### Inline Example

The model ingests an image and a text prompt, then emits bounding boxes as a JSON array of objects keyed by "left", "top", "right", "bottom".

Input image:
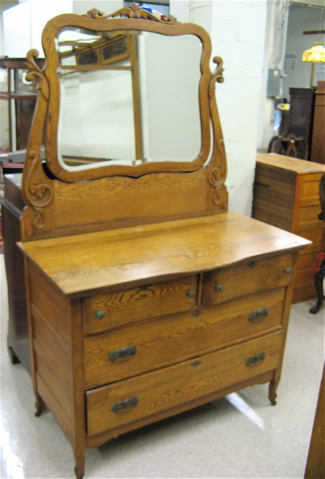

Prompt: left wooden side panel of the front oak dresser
[{"left": 27, "top": 261, "right": 74, "bottom": 440}]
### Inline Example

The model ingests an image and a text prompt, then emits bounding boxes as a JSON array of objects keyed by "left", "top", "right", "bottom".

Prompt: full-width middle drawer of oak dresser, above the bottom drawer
[{"left": 84, "top": 288, "right": 285, "bottom": 389}]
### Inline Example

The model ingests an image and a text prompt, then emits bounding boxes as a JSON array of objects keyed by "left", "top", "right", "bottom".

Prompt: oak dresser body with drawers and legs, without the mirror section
[{"left": 21, "top": 213, "right": 308, "bottom": 477}]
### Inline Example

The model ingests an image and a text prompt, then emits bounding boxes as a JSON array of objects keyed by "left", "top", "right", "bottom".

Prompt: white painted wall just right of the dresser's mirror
[{"left": 170, "top": 0, "right": 267, "bottom": 215}]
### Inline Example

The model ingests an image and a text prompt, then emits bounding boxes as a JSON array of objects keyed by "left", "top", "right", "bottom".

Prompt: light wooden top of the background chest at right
[{"left": 256, "top": 153, "right": 325, "bottom": 175}]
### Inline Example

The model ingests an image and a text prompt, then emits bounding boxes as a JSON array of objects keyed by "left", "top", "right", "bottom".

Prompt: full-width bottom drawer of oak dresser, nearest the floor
[{"left": 86, "top": 332, "right": 283, "bottom": 436}]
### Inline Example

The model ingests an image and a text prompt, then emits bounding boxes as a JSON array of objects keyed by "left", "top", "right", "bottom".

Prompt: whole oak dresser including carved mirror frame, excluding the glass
[{"left": 10, "top": 4, "right": 309, "bottom": 478}]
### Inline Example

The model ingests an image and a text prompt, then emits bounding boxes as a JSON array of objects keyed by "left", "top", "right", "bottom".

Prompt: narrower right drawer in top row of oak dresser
[{"left": 203, "top": 254, "right": 293, "bottom": 305}]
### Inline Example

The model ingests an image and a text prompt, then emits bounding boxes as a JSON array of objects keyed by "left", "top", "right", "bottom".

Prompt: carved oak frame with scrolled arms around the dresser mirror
[{"left": 26, "top": 3, "right": 225, "bottom": 182}]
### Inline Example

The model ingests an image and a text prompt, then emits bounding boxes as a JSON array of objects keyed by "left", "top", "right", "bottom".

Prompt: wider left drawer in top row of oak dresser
[{"left": 83, "top": 275, "right": 197, "bottom": 334}]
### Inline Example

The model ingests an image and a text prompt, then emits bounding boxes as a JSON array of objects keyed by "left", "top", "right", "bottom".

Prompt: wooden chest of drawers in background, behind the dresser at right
[{"left": 252, "top": 154, "right": 325, "bottom": 302}]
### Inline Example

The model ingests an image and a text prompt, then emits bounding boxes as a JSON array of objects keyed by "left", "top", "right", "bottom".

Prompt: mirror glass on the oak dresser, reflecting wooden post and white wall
[{"left": 57, "top": 29, "right": 202, "bottom": 170}]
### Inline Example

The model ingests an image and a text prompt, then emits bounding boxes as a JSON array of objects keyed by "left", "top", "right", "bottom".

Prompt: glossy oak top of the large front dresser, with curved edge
[{"left": 19, "top": 213, "right": 310, "bottom": 297}]
